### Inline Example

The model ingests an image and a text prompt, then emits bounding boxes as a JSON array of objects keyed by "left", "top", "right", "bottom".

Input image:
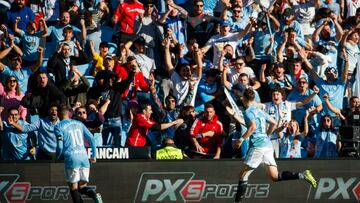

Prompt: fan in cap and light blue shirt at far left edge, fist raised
[{"left": 0, "top": 47, "right": 44, "bottom": 94}]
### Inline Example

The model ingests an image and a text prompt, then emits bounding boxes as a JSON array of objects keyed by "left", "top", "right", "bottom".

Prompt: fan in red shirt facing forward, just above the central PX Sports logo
[{"left": 190, "top": 104, "right": 224, "bottom": 159}]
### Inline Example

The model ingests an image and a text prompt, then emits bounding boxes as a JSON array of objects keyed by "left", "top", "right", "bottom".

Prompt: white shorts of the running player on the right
[{"left": 244, "top": 146, "right": 277, "bottom": 169}]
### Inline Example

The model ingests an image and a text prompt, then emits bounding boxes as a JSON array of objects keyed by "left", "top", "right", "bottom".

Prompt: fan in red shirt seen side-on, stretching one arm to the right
[{"left": 126, "top": 103, "right": 184, "bottom": 147}]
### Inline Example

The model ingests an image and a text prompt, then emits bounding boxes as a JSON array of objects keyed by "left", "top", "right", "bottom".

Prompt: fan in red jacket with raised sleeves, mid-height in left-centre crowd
[{"left": 114, "top": 56, "right": 149, "bottom": 99}]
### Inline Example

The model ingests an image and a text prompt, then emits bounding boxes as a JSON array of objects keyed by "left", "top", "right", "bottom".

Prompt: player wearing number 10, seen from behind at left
[{"left": 54, "top": 106, "right": 102, "bottom": 203}]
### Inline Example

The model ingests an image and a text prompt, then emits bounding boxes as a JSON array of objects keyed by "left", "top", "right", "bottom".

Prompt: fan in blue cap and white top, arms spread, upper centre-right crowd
[{"left": 201, "top": 17, "right": 253, "bottom": 67}]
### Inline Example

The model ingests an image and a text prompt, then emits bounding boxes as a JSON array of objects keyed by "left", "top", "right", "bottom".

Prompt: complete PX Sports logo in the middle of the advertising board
[{"left": 134, "top": 172, "right": 270, "bottom": 202}]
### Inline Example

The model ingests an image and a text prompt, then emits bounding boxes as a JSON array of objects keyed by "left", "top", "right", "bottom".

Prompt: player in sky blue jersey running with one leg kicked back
[{"left": 233, "top": 89, "right": 317, "bottom": 202}]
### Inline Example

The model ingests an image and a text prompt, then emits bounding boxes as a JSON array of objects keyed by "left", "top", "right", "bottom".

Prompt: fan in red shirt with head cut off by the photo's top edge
[{"left": 112, "top": 0, "right": 145, "bottom": 34}]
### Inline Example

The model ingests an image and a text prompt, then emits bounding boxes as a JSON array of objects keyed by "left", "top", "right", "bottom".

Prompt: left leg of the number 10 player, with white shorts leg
[{"left": 65, "top": 168, "right": 83, "bottom": 203}]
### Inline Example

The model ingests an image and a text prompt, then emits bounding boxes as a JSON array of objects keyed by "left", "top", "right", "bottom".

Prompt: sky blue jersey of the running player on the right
[{"left": 244, "top": 106, "right": 271, "bottom": 147}]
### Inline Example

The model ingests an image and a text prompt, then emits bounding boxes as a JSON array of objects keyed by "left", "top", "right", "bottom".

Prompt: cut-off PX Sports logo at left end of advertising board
[{"left": 0, "top": 174, "right": 96, "bottom": 203}]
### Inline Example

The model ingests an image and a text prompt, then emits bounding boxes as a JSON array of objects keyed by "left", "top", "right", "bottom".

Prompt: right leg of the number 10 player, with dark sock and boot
[{"left": 79, "top": 168, "right": 102, "bottom": 203}]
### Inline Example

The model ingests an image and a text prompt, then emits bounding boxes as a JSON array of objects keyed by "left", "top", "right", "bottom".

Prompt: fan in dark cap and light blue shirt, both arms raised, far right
[{"left": 307, "top": 48, "right": 348, "bottom": 127}]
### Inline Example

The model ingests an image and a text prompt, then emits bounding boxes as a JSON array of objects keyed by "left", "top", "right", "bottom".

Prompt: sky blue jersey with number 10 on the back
[{"left": 54, "top": 119, "right": 96, "bottom": 168}]
